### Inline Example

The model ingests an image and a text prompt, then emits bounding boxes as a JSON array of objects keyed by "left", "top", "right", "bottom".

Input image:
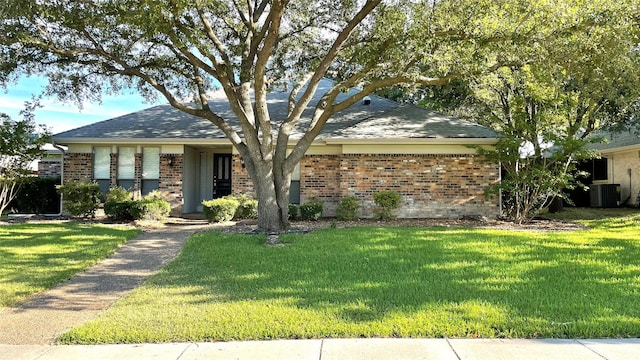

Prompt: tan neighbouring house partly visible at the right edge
[{"left": 591, "top": 132, "right": 640, "bottom": 206}]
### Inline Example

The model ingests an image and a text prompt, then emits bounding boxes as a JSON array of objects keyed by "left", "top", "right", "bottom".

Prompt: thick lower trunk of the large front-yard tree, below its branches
[{"left": 249, "top": 162, "right": 290, "bottom": 233}]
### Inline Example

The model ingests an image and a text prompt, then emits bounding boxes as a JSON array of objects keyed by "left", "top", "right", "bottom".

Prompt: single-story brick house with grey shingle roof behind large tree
[{"left": 53, "top": 81, "right": 499, "bottom": 218}]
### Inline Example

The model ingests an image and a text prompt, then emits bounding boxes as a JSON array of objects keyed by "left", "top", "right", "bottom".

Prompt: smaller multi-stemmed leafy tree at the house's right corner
[{"left": 404, "top": 1, "right": 640, "bottom": 223}]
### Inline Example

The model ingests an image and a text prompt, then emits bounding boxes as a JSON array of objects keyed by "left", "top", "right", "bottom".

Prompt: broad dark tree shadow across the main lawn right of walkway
[{"left": 138, "top": 228, "right": 640, "bottom": 337}]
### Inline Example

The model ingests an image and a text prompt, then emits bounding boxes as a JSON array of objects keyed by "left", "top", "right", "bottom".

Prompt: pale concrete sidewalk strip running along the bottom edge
[{"left": 0, "top": 339, "right": 640, "bottom": 360}]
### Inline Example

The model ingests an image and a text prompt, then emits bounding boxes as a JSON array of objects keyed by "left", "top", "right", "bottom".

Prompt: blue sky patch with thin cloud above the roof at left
[{"left": 0, "top": 77, "right": 161, "bottom": 134}]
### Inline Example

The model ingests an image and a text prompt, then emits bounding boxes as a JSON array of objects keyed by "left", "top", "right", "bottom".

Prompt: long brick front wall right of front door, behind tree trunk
[{"left": 233, "top": 154, "right": 499, "bottom": 218}]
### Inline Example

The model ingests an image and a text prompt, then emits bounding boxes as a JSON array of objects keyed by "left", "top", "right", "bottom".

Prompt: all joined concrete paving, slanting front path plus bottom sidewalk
[{"left": 0, "top": 224, "right": 640, "bottom": 360}]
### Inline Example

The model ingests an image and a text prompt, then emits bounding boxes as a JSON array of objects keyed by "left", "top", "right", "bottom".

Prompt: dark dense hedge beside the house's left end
[{"left": 9, "top": 177, "right": 60, "bottom": 214}]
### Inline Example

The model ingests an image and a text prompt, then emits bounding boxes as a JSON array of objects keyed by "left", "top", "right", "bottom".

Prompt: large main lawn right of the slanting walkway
[{"left": 61, "top": 212, "right": 640, "bottom": 343}]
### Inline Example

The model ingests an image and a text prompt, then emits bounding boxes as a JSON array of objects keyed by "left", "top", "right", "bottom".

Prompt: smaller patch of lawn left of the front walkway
[{"left": 0, "top": 223, "right": 139, "bottom": 308}]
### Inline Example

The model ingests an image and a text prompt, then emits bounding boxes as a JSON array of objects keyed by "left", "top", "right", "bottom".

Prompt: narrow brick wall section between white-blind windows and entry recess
[{"left": 158, "top": 154, "right": 184, "bottom": 215}]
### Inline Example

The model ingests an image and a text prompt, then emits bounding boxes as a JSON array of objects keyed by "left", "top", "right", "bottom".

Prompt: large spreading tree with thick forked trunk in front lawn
[{"left": 0, "top": 0, "right": 620, "bottom": 231}]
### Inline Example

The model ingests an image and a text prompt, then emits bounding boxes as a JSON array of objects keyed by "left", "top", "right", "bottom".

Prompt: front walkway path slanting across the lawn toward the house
[{"left": 0, "top": 223, "right": 208, "bottom": 345}]
